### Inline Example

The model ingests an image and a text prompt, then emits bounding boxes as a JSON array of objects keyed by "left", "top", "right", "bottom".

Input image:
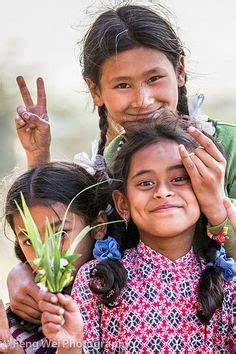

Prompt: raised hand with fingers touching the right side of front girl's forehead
[{"left": 179, "top": 127, "right": 227, "bottom": 226}]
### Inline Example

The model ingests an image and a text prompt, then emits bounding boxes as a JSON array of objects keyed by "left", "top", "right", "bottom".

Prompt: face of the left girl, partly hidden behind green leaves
[{"left": 13, "top": 202, "right": 99, "bottom": 270}]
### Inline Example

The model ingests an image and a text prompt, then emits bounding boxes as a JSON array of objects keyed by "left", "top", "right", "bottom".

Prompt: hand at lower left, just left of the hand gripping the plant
[{"left": 7, "top": 263, "right": 42, "bottom": 324}]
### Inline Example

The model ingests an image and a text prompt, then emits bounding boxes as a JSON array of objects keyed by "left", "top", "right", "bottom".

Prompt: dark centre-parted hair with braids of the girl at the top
[{"left": 80, "top": 5, "right": 188, "bottom": 155}]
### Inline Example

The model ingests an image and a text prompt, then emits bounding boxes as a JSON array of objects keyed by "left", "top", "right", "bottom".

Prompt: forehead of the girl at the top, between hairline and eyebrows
[{"left": 101, "top": 46, "right": 174, "bottom": 77}]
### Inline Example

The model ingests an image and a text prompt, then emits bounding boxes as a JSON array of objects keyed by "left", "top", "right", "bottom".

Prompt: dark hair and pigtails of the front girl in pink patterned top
[{"left": 90, "top": 112, "right": 223, "bottom": 324}]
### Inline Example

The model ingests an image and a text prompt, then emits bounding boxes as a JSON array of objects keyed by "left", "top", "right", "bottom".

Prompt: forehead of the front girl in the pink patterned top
[{"left": 129, "top": 139, "right": 182, "bottom": 175}]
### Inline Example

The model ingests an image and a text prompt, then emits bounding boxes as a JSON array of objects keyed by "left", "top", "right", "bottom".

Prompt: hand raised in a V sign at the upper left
[{"left": 15, "top": 76, "right": 51, "bottom": 167}]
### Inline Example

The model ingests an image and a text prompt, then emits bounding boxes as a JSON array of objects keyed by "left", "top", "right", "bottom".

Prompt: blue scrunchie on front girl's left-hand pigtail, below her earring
[{"left": 93, "top": 236, "right": 121, "bottom": 261}]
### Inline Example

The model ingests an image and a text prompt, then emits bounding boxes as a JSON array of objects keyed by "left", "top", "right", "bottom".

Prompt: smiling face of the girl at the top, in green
[{"left": 88, "top": 46, "right": 185, "bottom": 134}]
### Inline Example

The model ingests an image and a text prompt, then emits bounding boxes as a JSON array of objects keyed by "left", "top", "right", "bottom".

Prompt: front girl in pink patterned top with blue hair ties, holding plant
[{"left": 39, "top": 117, "right": 233, "bottom": 353}]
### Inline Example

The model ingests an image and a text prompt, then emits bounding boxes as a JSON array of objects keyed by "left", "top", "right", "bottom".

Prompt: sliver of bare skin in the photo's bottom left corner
[{"left": 0, "top": 300, "right": 24, "bottom": 354}]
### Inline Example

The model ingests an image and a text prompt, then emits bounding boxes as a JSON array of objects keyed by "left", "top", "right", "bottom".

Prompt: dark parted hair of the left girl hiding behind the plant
[{"left": 5, "top": 162, "right": 111, "bottom": 332}]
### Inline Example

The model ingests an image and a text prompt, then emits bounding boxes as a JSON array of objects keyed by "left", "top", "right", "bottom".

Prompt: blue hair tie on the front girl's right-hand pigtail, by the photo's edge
[{"left": 206, "top": 246, "right": 235, "bottom": 281}]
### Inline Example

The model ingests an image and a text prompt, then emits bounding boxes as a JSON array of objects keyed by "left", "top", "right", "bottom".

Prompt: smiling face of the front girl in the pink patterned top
[{"left": 115, "top": 139, "right": 200, "bottom": 245}]
